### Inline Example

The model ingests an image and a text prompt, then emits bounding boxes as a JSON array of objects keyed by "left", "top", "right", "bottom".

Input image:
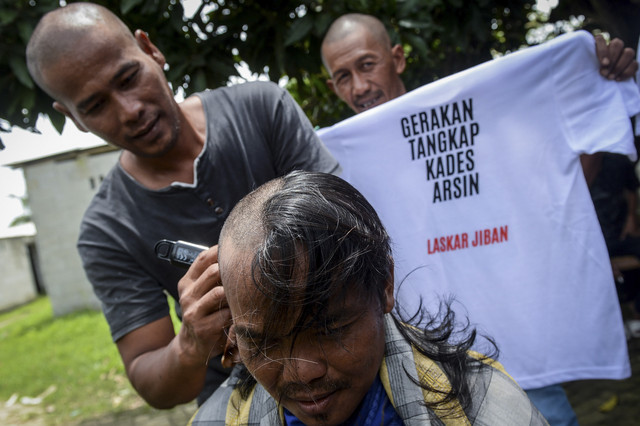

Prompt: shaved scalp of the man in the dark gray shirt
[{"left": 26, "top": 3, "right": 135, "bottom": 98}]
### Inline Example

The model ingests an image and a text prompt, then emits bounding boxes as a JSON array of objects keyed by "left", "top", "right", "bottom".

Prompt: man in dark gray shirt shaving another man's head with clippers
[{"left": 27, "top": 3, "right": 339, "bottom": 408}]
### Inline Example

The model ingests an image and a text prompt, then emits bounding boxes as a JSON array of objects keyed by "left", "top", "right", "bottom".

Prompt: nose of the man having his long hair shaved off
[{"left": 282, "top": 342, "right": 327, "bottom": 384}]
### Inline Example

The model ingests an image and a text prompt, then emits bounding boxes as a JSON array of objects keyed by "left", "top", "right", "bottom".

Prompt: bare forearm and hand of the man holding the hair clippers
[{"left": 117, "top": 246, "right": 231, "bottom": 408}]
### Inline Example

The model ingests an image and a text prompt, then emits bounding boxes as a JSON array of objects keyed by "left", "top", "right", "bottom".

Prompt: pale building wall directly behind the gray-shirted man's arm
[{"left": 23, "top": 147, "right": 120, "bottom": 315}]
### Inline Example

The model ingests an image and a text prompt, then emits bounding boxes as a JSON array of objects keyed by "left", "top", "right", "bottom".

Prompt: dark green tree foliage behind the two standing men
[{"left": 0, "top": 0, "right": 638, "bottom": 141}]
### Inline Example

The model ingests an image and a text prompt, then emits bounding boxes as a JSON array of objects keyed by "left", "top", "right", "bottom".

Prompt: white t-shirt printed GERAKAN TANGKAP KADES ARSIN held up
[{"left": 319, "top": 31, "right": 640, "bottom": 389}]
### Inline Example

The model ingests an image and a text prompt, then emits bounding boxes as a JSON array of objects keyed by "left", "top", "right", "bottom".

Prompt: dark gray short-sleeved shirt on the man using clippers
[{"left": 78, "top": 82, "right": 339, "bottom": 402}]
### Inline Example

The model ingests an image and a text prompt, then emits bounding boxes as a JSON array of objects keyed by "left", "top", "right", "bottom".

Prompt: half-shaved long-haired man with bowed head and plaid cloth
[{"left": 192, "top": 172, "right": 546, "bottom": 425}]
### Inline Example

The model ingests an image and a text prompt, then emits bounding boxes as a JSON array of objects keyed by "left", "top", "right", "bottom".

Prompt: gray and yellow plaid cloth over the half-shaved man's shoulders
[{"left": 189, "top": 314, "right": 547, "bottom": 426}]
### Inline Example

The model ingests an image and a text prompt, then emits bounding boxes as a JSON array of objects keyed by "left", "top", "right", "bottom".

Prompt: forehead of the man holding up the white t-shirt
[{"left": 323, "top": 26, "right": 390, "bottom": 73}]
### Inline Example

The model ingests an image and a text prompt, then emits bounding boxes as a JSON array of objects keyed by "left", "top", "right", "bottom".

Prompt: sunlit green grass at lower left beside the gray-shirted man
[{"left": 0, "top": 297, "right": 188, "bottom": 425}]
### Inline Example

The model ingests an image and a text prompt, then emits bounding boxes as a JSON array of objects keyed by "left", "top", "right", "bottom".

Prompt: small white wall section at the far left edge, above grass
[{"left": 0, "top": 231, "right": 38, "bottom": 311}]
